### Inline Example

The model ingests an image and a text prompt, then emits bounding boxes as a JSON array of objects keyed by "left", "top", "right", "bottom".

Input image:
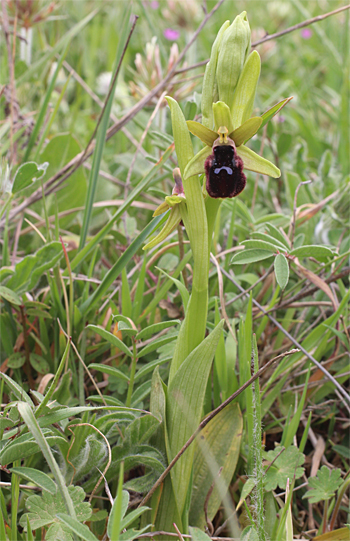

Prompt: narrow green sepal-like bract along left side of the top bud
[{"left": 201, "top": 21, "right": 230, "bottom": 130}]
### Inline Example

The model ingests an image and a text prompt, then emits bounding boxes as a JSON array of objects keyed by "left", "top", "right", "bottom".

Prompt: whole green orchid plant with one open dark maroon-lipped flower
[{"left": 144, "top": 12, "right": 291, "bottom": 533}]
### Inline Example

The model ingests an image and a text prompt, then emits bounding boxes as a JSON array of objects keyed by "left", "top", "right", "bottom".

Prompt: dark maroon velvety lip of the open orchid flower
[{"left": 204, "top": 137, "right": 246, "bottom": 199}]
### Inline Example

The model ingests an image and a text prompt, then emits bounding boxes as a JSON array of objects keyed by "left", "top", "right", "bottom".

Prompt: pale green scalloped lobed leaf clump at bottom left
[{"left": 20, "top": 486, "right": 92, "bottom": 541}]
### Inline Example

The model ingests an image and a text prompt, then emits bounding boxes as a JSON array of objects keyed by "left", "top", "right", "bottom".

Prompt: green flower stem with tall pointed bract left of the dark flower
[{"left": 167, "top": 97, "right": 209, "bottom": 382}]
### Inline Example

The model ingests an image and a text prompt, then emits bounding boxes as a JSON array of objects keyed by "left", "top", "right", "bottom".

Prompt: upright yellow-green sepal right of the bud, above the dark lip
[{"left": 231, "top": 51, "right": 261, "bottom": 129}]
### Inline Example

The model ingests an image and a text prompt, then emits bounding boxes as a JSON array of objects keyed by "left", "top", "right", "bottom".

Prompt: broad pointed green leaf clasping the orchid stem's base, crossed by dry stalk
[{"left": 167, "top": 321, "right": 224, "bottom": 513}]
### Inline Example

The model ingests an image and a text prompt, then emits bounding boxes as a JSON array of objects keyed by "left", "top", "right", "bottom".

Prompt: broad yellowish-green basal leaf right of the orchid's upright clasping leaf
[{"left": 190, "top": 402, "right": 243, "bottom": 529}]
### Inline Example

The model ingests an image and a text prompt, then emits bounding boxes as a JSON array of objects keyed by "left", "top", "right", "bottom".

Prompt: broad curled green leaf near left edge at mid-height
[{"left": 7, "top": 241, "right": 63, "bottom": 293}]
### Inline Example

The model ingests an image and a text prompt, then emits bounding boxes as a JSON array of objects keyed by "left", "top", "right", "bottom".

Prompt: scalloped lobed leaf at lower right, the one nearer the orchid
[{"left": 265, "top": 445, "right": 305, "bottom": 492}]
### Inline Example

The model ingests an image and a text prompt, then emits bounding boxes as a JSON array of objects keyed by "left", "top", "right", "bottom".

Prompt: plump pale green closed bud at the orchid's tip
[{"left": 216, "top": 11, "right": 250, "bottom": 109}]
